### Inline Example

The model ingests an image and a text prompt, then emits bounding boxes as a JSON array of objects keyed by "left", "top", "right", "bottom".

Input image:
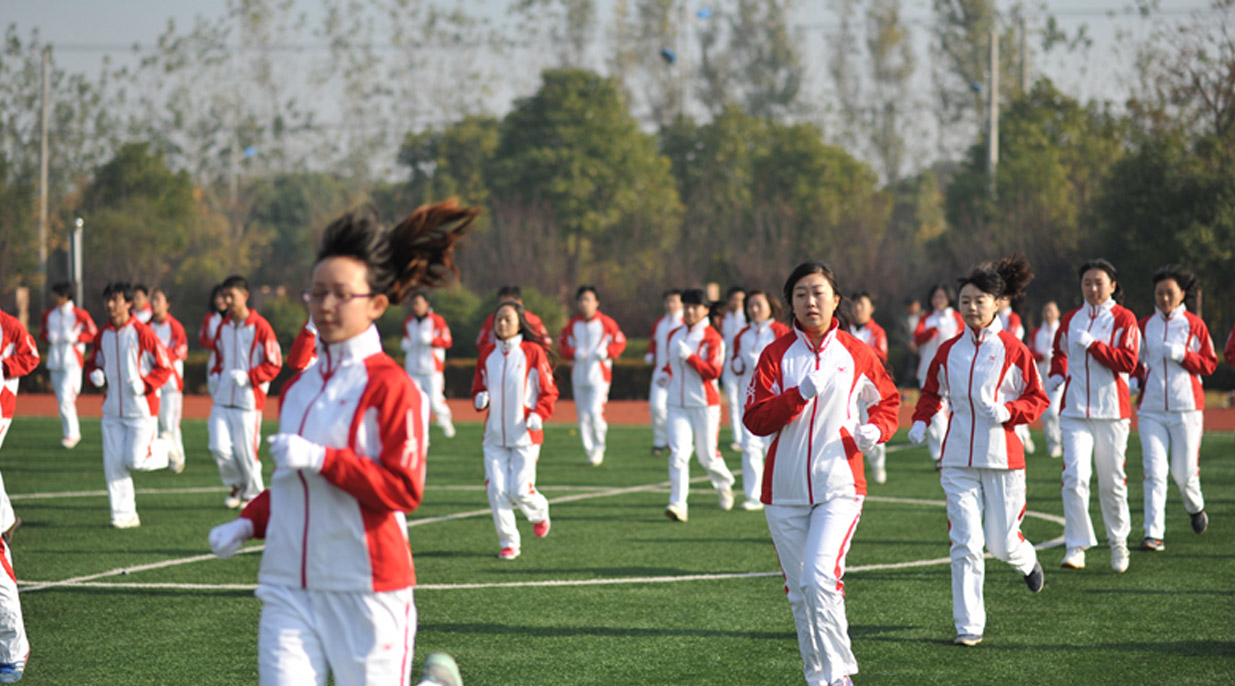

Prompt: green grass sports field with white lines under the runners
[{"left": 0, "top": 418, "right": 1235, "bottom": 686}]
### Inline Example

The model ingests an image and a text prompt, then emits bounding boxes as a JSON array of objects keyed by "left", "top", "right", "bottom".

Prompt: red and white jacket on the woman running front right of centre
[{"left": 743, "top": 320, "right": 900, "bottom": 506}]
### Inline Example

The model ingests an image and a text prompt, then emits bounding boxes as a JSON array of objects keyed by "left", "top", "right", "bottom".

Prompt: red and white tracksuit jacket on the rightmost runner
[{"left": 1136, "top": 305, "right": 1218, "bottom": 412}]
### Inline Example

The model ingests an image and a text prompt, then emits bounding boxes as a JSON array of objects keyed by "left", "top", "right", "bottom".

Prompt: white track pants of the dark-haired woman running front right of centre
[{"left": 763, "top": 496, "right": 866, "bottom": 686}]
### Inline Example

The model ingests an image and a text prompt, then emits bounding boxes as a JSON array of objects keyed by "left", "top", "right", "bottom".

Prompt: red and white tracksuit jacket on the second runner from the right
[{"left": 1051, "top": 299, "right": 1141, "bottom": 419}]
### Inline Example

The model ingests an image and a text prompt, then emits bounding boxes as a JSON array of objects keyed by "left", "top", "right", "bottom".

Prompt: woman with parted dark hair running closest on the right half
[{"left": 742, "top": 262, "right": 900, "bottom": 686}]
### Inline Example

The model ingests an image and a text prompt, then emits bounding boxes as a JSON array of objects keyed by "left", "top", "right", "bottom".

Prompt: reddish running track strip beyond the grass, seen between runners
[{"left": 16, "top": 393, "right": 1235, "bottom": 431}]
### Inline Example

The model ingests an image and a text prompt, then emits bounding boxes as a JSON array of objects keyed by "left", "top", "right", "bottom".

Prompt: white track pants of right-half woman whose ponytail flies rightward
[{"left": 940, "top": 467, "right": 1037, "bottom": 635}]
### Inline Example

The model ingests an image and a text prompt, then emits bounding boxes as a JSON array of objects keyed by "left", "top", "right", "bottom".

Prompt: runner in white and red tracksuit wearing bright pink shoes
[{"left": 472, "top": 302, "right": 557, "bottom": 560}]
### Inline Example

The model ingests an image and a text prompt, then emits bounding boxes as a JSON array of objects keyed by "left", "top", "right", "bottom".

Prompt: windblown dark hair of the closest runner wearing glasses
[{"left": 317, "top": 198, "right": 480, "bottom": 304}]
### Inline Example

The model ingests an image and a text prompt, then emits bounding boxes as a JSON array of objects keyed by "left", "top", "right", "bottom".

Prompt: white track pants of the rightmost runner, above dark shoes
[{"left": 1136, "top": 409, "right": 1205, "bottom": 539}]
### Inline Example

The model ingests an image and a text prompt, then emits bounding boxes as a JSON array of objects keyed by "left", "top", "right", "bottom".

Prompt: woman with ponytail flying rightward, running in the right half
[{"left": 909, "top": 256, "right": 1049, "bottom": 645}]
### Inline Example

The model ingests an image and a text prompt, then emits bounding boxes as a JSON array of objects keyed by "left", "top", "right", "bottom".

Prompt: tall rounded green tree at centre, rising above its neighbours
[{"left": 487, "top": 70, "right": 682, "bottom": 297}]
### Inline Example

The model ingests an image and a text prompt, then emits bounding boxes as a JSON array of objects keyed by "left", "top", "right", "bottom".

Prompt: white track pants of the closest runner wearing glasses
[{"left": 256, "top": 583, "right": 416, "bottom": 686}]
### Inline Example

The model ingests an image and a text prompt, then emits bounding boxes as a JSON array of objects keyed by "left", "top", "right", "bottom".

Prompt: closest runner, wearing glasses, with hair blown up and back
[{"left": 210, "top": 200, "right": 477, "bottom": 686}]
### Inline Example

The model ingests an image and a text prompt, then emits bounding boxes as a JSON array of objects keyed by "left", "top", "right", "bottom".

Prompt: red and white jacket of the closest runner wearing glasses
[{"left": 241, "top": 329, "right": 425, "bottom": 592}]
